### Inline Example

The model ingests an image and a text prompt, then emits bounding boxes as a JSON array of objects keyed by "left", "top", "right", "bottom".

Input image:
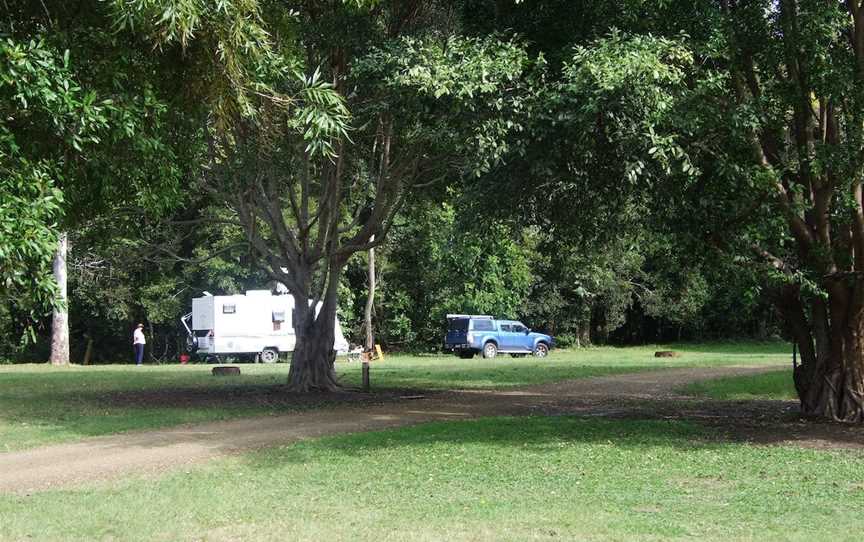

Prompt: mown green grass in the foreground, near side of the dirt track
[{"left": 0, "top": 417, "right": 864, "bottom": 542}]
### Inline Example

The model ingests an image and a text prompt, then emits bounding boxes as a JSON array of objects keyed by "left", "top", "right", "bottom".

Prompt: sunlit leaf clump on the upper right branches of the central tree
[{"left": 352, "top": 37, "right": 544, "bottom": 176}]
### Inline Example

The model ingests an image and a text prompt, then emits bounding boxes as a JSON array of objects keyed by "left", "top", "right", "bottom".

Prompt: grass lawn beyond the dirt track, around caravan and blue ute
[{"left": 0, "top": 343, "right": 788, "bottom": 452}]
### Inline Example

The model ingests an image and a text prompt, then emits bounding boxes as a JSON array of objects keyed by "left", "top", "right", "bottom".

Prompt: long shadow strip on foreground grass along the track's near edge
[{"left": 236, "top": 416, "right": 864, "bottom": 480}]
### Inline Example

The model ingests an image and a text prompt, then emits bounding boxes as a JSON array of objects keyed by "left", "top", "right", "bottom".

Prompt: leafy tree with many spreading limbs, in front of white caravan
[{"left": 108, "top": 1, "right": 529, "bottom": 391}]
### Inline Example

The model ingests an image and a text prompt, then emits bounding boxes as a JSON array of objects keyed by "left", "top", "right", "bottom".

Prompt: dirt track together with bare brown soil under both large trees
[{"left": 0, "top": 367, "right": 864, "bottom": 493}]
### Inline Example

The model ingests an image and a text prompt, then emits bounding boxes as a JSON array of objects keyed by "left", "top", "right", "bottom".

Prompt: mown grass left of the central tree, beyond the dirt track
[{"left": 0, "top": 365, "right": 284, "bottom": 452}]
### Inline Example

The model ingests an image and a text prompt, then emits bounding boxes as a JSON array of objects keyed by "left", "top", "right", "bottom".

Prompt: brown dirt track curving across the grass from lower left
[{"left": 0, "top": 366, "right": 848, "bottom": 493}]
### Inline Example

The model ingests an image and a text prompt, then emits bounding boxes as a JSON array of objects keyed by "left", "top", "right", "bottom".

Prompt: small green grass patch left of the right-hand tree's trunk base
[{"left": 683, "top": 368, "right": 797, "bottom": 401}]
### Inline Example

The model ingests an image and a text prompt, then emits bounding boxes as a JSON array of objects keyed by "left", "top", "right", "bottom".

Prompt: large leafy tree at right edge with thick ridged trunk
[{"left": 528, "top": 0, "right": 864, "bottom": 421}]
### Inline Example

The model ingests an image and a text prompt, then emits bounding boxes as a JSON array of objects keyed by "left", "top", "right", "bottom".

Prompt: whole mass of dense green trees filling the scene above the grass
[{"left": 0, "top": 0, "right": 864, "bottom": 420}]
